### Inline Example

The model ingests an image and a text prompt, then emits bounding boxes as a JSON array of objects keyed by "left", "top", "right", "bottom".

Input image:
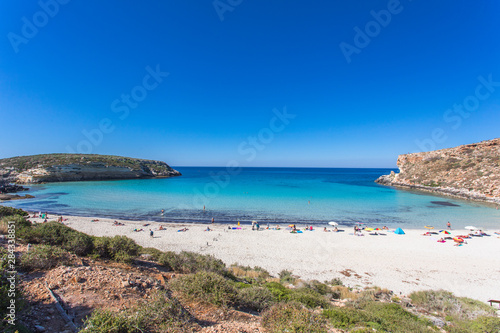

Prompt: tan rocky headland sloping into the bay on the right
[{"left": 376, "top": 138, "right": 500, "bottom": 204}]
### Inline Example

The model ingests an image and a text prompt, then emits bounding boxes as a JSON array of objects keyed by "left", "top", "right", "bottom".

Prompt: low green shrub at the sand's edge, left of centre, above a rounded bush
[{"left": 158, "top": 251, "right": 232, "bottom": 277}]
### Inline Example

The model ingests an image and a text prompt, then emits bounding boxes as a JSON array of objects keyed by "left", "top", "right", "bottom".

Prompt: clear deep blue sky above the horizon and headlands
[{"left": 0, "top": 0, "right": 500, "bottom": 167}]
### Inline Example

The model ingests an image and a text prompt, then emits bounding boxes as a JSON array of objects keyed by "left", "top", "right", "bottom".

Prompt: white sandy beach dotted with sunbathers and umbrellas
[{"left": 31, "top": 216, "right": 500, "bottom": 301}]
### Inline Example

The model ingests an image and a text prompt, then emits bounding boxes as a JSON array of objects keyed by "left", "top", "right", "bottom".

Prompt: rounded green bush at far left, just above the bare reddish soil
[{"left": 21, "top": 245, "right": 70, "bottom": 271}]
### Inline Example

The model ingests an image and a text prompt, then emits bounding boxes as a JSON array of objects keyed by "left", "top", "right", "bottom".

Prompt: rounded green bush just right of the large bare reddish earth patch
[{"left": 170, "top": 272, "right": 238, "bottom": 306}]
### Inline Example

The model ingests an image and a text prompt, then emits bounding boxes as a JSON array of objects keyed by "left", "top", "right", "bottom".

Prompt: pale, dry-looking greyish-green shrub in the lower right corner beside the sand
[{"left": 410, "top": 290, "right": 495, "bottom": 320}]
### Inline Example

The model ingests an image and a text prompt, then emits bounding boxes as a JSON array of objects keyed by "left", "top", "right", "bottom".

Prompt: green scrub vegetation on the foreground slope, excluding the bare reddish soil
[{"left": 0, "top": 207, "right": 500, "bottom": 332}]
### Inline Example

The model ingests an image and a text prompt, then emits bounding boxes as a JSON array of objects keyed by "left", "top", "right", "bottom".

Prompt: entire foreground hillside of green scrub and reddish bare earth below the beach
[{"left": 0, "top": 207, "right": 500, "bottom": 333}]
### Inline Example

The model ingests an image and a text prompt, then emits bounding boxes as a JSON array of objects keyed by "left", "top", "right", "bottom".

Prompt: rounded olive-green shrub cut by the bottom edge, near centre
[{"left": 262, "top": 303, "right": 328, "bottom": 333}]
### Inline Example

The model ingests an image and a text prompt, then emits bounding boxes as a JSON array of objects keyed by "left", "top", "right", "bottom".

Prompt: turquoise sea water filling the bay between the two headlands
[{"left": 4, "top": 167, "right": 500, "bottom": 229}]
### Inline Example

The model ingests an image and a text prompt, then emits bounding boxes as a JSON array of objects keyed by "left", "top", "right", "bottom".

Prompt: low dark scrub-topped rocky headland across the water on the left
[{"left": 0, "top": 154, "right": 181, "bottom": 184}]
